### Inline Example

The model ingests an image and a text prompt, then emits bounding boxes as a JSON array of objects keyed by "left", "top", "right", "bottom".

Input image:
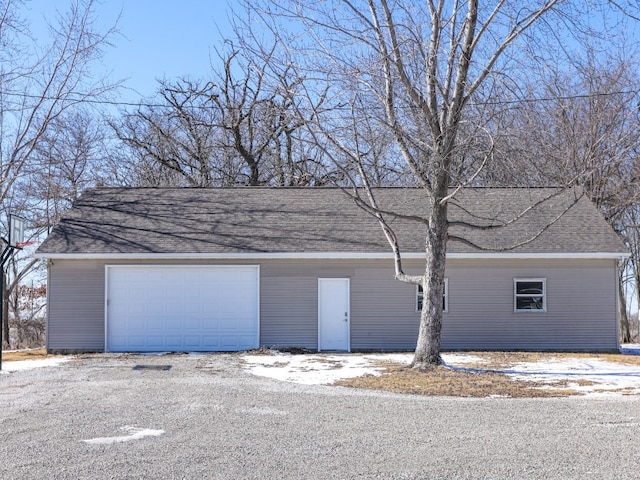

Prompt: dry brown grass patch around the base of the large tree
[{"left": 337, "top": 352, "right": 640, "bottom": 398}]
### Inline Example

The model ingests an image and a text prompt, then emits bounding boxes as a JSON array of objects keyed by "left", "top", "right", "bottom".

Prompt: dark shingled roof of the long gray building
[{"left": 37, "top": 187, "right": 627, "bottom": 257}]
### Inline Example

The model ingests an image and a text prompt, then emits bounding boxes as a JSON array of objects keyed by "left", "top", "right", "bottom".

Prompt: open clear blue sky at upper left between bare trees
[{"left": 28, "top": 0, "right": 238, "bottom": 102}]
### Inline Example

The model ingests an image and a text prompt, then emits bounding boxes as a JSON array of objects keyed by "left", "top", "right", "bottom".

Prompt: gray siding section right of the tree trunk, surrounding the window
[{"left": 442, "top": 260, "right": 618, "bottom": 350}]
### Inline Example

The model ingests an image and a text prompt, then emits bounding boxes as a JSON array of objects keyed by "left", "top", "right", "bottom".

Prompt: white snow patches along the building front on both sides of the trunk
[{"left": 243, "top": 345, "right": 640, "bottom": 396}]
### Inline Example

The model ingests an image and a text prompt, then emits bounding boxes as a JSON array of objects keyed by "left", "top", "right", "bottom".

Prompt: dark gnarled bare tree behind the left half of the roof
[{"left": 112, "top": 44, "right": 332, "bottom": 187}]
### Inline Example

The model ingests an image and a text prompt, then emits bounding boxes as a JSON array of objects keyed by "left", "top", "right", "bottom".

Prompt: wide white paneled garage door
[{"left": 106, "top": 265, "right": 260, "bottom": 352}]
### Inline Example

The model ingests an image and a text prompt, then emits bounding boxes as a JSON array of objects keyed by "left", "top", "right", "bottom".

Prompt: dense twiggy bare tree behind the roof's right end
[{"left": 478, "top": 51, "right": 640, "bottom": 342}]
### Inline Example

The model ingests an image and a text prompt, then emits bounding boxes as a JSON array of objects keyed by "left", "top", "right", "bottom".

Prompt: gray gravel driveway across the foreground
[{"left": 0, "top": 354, "right": 640, "bottom": 480}]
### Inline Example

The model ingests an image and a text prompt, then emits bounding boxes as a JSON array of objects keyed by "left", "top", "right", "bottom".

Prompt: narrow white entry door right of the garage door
[{"left": 318, "top": 278, "right": 350, "bottom": 351}]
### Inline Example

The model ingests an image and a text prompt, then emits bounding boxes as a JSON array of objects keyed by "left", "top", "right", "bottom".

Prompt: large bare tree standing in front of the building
[{"left": 239, "top": 0, "right": 624, "bottom": 368}]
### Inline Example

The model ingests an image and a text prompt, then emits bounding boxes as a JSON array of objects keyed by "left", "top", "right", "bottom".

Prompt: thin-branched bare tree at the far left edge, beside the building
[{"left": 0, "top": 0, "right": 114, "bottom": 343}]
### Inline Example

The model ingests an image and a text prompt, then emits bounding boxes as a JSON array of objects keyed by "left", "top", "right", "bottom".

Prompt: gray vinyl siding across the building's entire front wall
[{"left": 48, "top": 260, "right": 618, "bottom": 351}]
